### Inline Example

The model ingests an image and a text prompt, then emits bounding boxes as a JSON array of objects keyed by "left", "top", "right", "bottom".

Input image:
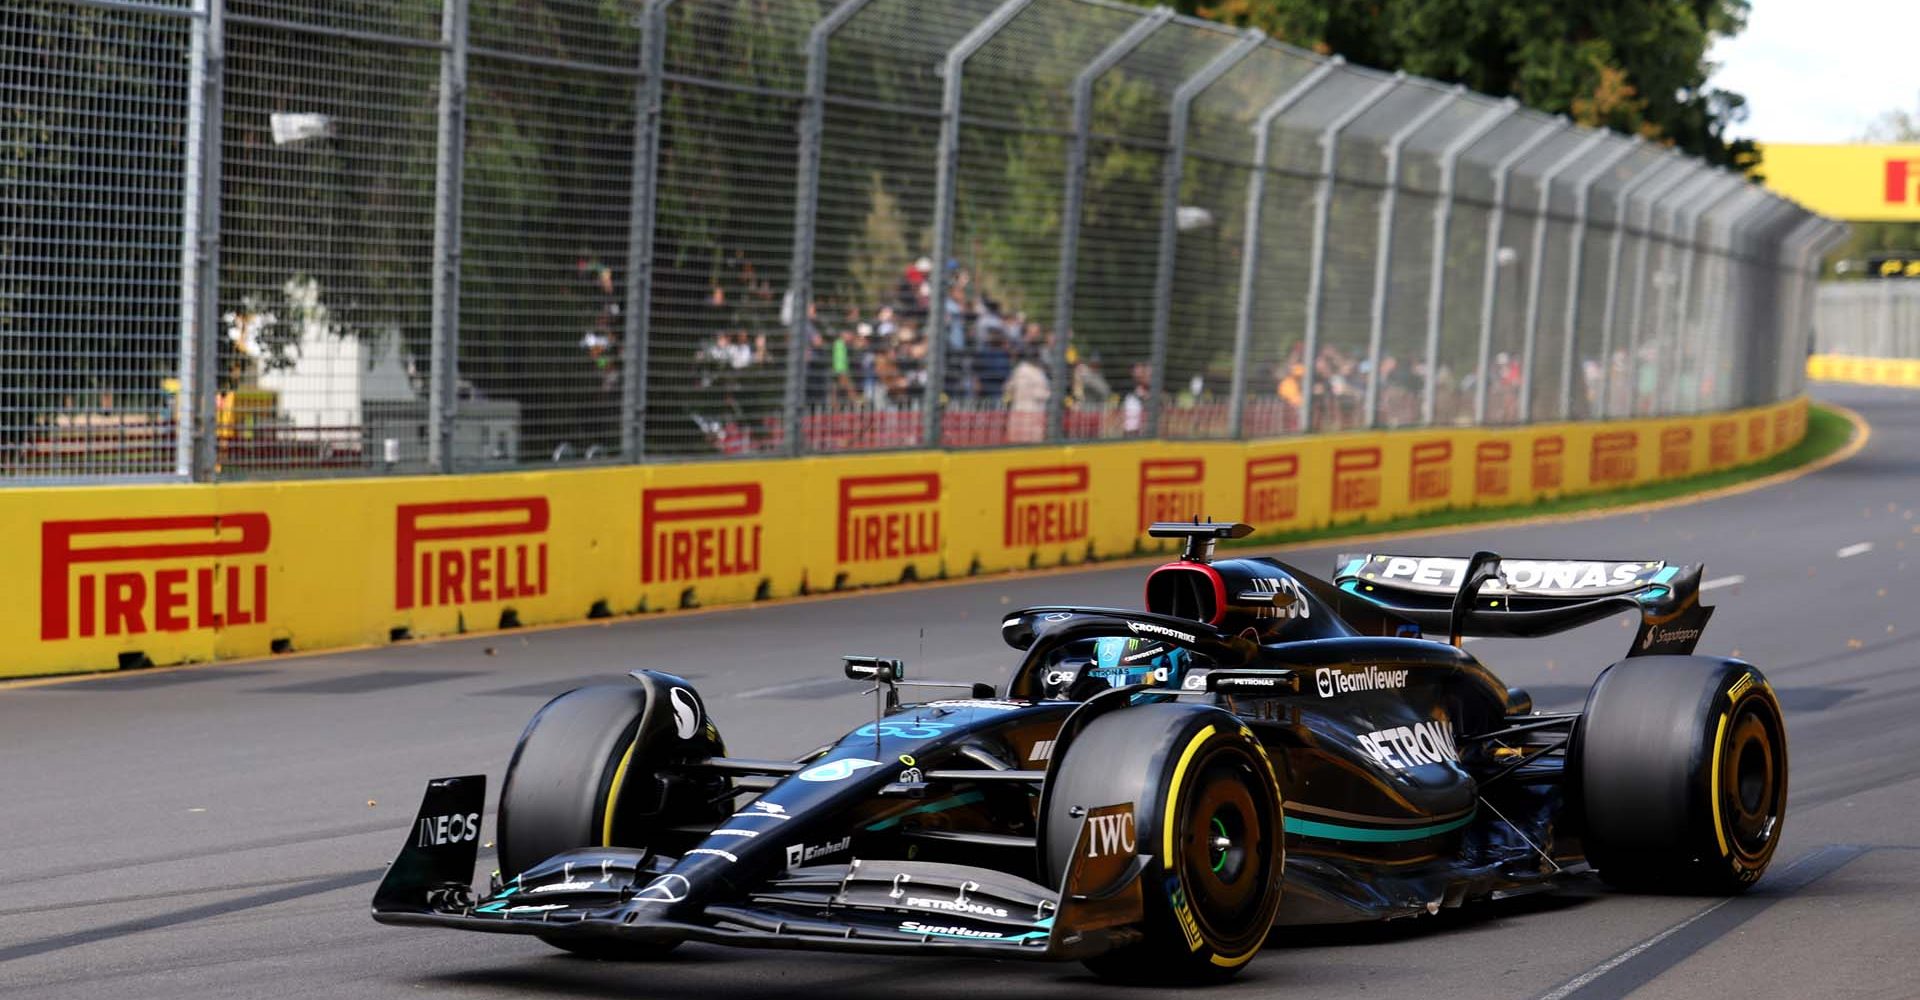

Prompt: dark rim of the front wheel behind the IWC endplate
[{"left": 1175, "top": 747, "right": 1279, "bottom": 950}]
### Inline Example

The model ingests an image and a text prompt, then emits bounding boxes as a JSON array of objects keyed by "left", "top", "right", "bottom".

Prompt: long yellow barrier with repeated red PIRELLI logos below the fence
[{"left": 0, "top": 399, "right": 1807, "bottom": 676}]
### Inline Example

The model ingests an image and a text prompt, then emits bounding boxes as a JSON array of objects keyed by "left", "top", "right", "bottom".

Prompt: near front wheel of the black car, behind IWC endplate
[{"left": 1043, "top": 704, "right": 1284, "bottom": 985}]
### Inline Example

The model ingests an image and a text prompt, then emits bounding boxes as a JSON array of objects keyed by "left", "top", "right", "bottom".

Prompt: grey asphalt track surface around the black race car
[{"left": 0, "top": 388, "right": 1920, "bottom": 1000}]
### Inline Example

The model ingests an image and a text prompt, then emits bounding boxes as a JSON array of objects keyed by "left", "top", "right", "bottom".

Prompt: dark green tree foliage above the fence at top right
[{"left": 1144, "top": 0, "right": 1759, "bottom": 169}]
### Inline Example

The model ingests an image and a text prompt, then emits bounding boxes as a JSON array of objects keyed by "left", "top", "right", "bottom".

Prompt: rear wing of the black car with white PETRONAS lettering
[{"left": 1332, "top": 553, "right": 1713, "bottom": 656}]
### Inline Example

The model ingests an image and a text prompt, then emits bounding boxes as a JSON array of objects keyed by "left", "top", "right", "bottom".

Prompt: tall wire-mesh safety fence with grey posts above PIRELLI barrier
[{"left": 0, "top": 0, "right": 1839, "bottom": 482}]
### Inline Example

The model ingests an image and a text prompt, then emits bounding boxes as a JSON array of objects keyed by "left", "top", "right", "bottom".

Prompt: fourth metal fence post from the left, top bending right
[{"left": 779, "top": 0, "right": 874, "bottom": 455}]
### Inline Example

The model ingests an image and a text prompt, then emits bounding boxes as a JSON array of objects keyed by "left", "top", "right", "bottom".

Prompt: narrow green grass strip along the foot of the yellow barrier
[{"left": 1229, "top": 403, "right": 1853, "bottom": 545}]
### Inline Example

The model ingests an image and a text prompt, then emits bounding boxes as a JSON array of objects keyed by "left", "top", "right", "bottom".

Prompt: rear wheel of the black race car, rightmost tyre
[{"left": 1574, "top": 656, "right": 1788, "bottom": 894}]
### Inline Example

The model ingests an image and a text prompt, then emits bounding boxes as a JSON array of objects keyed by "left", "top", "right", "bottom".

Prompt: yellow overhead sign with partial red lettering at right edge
[{"left": 1761, "top": 142, "right": 1920, "bottom": 223}]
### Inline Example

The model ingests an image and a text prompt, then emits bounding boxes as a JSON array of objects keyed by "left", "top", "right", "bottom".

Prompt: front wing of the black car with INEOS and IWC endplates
[{"left": 372, "top": 775, "right": 1146, "bottom": 960}]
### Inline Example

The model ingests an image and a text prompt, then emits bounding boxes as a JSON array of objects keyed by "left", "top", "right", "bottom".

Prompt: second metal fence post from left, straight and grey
[{"left": 426, "top": 0, "right": 467, "bottom": 472}]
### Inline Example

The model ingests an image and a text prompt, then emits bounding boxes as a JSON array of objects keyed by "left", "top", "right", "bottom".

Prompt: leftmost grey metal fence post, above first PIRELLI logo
[{"left": 173, "top": 0, "right": 227, "bottom": 482}]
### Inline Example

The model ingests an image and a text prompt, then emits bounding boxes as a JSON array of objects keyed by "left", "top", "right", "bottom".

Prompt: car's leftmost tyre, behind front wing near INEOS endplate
[{"left": 495, "top": 674, "right": 724, "bottom": 962}]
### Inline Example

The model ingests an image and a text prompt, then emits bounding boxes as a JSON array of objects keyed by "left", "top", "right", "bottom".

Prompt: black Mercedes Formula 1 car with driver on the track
[{"left": 372, "top": 522, "right": 1788, "bottom": 983}]
